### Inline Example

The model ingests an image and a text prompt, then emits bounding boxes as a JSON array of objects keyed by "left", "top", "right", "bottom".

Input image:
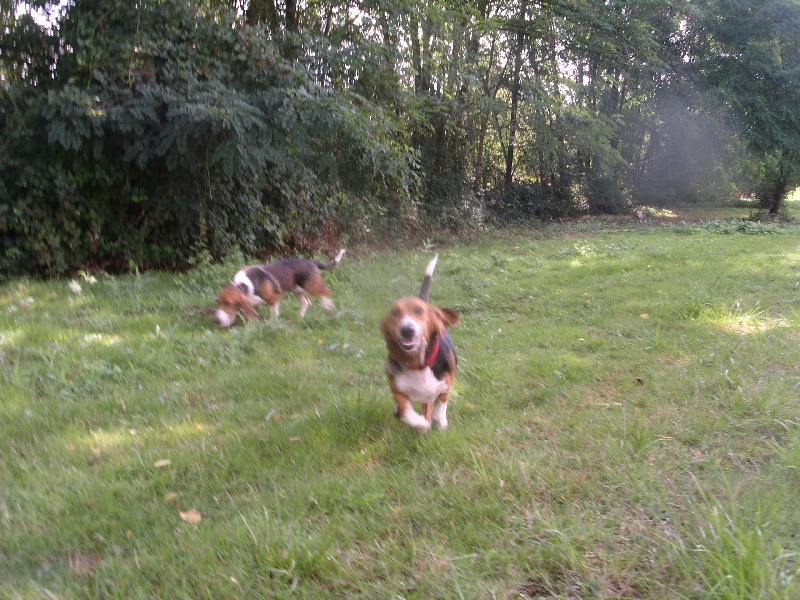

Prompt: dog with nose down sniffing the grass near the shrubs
[{"left": 215, "top": 249, "right": 345, "bottom": 327}]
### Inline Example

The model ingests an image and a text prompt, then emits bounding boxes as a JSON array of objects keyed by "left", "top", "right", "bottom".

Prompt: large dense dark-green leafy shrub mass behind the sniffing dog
[{"left": 0, "top": 0, "right": 414, "bottom": 275}]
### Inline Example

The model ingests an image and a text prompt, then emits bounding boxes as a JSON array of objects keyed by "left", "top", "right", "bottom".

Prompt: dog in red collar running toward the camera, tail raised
[{"left": 381, "top": 254, "right": 461, "bottom": 433}]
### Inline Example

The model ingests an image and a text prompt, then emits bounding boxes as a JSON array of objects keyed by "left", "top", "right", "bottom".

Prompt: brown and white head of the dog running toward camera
[{"left": 381, "top": 297, "right": 461, "bottom": 364}]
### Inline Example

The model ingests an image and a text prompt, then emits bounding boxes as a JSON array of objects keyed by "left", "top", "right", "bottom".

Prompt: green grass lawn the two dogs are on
[{"left": 0, "top": 200, "right": 800, "bottom": 599}]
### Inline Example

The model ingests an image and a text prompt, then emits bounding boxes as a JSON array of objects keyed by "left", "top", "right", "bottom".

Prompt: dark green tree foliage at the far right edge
[{"left": 692, "top": 0, "right": 800, "bottom": 214}]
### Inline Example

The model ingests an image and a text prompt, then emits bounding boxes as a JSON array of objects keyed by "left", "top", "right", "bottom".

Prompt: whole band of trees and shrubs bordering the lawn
[{"left": 0, "top": 0, "right": 800, "bottom": 278}]
